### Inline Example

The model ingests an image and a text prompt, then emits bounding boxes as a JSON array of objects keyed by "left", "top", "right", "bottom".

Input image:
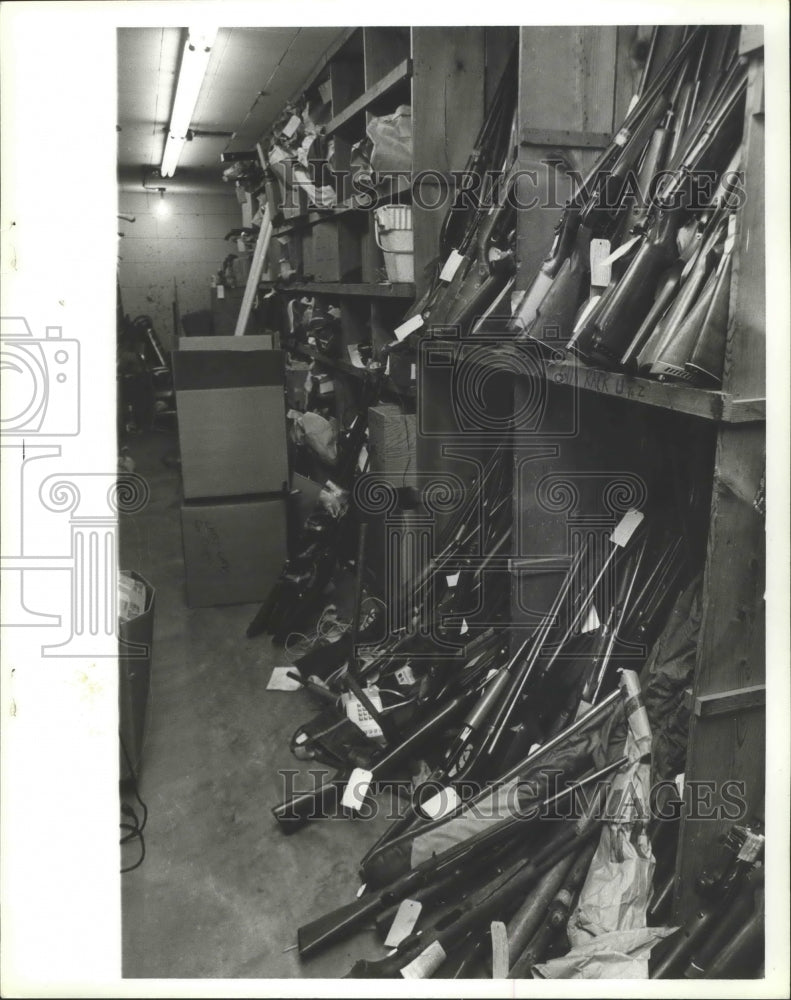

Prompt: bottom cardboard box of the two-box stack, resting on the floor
[{"left": 181, "top": 495, "right": 286, "bottom": 608}]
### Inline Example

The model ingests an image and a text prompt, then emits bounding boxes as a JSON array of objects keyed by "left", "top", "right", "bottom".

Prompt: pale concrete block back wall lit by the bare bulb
[{"left": 118, "top": 191, "right": 242, "bottom": 349}]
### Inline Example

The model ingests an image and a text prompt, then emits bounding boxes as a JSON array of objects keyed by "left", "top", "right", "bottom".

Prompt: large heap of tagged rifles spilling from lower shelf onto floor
[{"left": 272, "top": 484, "right": 708, "bottom": 977}]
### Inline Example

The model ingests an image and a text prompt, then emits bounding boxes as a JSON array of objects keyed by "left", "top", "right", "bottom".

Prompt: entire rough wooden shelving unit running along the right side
[{"left": 243, "top": 25, "right": 766, "bottom": 917}]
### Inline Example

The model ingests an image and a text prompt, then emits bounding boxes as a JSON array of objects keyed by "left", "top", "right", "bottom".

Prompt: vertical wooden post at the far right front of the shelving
[{"left": 674, "top": 33, "right": 766, "bottom": 922}]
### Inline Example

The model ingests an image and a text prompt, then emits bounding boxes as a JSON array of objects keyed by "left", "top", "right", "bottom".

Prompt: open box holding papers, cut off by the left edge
[{"left": 118, "top": 572, "right": 156, "bottom": 781}]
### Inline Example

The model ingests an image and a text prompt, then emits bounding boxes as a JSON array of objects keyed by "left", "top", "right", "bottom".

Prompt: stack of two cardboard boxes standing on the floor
[{"left": 173, "top": 336, "right": 288, "bottom": 607}]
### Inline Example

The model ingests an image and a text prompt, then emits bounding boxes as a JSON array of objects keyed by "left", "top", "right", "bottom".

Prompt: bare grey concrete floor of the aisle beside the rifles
[{"left": 120, "top": 432, "right": 396, "bottom": 979}]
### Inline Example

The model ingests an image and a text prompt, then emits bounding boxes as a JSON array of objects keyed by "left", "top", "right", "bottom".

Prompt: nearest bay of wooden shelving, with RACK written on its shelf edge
[{"left": 418, "top": 26, "right": 766, "bottom": 922}]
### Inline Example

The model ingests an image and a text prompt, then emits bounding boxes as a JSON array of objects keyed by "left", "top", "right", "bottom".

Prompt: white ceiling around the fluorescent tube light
[{"left": 118, "top": 27, "right": 349, "bottom": 192}]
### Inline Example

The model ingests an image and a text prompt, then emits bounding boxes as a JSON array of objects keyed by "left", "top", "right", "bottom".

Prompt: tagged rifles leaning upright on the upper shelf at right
[{"left": 511, "top": 26, "right": 747, "bottom": 388}]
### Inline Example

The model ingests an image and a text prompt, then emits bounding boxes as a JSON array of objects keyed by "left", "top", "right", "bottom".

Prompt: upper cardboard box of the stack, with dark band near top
[{"left": 173, "top": 337, "right": 288, "bottom": 500}]
